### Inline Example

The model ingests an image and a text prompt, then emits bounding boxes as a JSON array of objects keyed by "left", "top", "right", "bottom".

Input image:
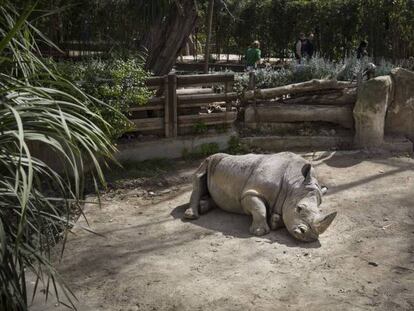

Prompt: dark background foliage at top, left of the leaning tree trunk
[{"left": 12, "top": 0, "right": 174, "bottom": 49}]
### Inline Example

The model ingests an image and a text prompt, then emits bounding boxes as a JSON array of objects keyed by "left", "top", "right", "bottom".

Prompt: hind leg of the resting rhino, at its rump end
[{"left": 184, "top": 160, "right": 208, "bottom": 219}]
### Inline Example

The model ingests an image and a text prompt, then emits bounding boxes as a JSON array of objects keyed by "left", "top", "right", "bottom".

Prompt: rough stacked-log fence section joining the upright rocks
[{"left": 243, "top": 74, "right": 357, "bottom": 129}]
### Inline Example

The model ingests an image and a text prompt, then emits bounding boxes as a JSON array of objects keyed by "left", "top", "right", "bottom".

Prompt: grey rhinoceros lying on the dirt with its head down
[{"left": 184, "top": 152, "right": 336, "bottom": 241}]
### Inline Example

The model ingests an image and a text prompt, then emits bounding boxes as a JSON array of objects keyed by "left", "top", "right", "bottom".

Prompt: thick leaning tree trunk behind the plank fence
[{"left": 142, "top": 0, "right": 197, "bottom": 75}]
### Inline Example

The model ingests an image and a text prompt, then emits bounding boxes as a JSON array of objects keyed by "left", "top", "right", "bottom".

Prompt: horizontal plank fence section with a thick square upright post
[{"left": 130, "top": 73, "right": 237, "bottom": 137}]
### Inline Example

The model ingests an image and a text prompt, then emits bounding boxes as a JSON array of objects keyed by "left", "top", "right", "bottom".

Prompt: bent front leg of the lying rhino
[{"left": 241, "top": 195, "right": 270, "bottom": 236}]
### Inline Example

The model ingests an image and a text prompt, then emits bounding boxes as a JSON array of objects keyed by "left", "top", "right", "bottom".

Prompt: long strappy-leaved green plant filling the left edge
[{"left": 0, "top": 0, "right": 114, "bottom": 311}]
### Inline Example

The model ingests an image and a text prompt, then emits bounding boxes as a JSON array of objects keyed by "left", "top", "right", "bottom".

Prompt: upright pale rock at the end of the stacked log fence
[{"left": 354, "top": 76, "right": 392, "bottom": 148}]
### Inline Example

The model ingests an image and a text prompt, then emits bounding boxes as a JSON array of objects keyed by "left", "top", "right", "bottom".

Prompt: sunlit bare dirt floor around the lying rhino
[{"left": 31, "top": 153, "right": 414, "bottom": 311}]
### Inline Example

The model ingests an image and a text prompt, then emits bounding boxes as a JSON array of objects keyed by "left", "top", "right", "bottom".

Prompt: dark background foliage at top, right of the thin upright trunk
[{"left": 215, "top": 0, "right": 414, "bottom": 59}]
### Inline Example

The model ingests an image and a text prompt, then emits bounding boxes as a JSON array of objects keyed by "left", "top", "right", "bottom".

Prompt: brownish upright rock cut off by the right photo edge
[{"left": 385, "top": 68, "right": 414, "bottom": 142}]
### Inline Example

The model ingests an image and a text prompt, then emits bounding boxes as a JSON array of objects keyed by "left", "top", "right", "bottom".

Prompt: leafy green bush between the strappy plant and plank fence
[{"left": 57, "top": 56, "right": 152, "bottom": 139}]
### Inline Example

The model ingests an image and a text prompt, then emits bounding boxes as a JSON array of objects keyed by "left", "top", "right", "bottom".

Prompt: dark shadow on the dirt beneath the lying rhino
[{"left": 170, "top": 203, "right": 321, "bottom": 248}]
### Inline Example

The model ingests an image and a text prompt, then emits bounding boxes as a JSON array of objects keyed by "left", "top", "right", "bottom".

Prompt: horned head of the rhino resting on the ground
[{"left": 282, "top": 164, "right": 336, "bottom": 242}]
